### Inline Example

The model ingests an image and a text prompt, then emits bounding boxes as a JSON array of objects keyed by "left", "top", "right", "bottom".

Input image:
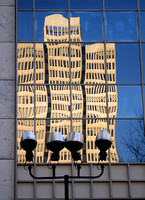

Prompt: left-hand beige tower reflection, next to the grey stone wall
[{"left": 17, "top": 43, "right": 48, "bottom": 163}]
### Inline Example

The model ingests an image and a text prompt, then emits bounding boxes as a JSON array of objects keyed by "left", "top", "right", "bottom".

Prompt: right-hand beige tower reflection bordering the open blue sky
[{"left": 85, "top": 43, "right": 118, "bottom": 162}]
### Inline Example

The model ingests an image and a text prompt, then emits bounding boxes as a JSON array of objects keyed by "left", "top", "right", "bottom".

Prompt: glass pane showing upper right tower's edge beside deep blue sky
[{"left": 114, "top": 43, "right": 141, "bottom": 83}]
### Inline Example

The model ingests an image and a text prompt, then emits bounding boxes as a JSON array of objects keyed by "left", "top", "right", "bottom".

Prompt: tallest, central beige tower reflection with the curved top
[{"left": 44, "top": 14, "right": 83, "bottom": 163}]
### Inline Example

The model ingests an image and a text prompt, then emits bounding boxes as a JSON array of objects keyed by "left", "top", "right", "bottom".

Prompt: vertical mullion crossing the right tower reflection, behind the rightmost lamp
[{"left": 103, "top": 0, "right": 112, "bottom": 198}]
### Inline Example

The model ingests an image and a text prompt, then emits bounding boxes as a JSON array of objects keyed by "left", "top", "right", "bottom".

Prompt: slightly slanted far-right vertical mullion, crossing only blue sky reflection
[{"left": 137, "top": 0, "right": 145, "bottom": 136}]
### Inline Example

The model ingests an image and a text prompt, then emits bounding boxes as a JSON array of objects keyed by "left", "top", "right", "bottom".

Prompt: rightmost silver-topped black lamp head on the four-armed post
[{"left": 95, "top": 130, "right": 112, "bottom": 160}]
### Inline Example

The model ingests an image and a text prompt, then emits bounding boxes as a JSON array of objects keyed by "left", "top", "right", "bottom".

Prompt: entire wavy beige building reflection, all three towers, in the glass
[{"left": 17, "top": 14, "right": 118, "bottom": 163}]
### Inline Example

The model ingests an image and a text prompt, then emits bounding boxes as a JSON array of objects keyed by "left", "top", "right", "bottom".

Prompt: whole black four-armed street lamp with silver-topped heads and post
[{"left": 21, "top": 130, "right": 112, "bottom": 200}]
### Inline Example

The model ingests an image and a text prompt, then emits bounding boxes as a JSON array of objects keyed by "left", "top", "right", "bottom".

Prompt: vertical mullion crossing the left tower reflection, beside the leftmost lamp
[{"left": 33, "top": 0, "right": 36, "bottom": 200}]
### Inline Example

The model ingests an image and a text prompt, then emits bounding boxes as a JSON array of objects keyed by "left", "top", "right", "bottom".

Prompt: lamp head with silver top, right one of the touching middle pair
[{"left": 65, "top": 132, "right": 84, "bottom": 161}]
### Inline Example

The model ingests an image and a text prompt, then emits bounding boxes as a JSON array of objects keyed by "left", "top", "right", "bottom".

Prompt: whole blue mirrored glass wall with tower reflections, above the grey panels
[{"left": 16, "top": 0, "right": 145, "bottom": 163}]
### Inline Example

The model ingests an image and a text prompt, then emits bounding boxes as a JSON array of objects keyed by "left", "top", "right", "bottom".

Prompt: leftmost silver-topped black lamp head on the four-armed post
[{"left": 20, "top": 131, "right": 37, "bottom": 161}]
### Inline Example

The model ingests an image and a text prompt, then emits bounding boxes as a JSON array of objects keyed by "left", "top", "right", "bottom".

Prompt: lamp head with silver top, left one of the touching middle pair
[{"left": 46, "top": 132, "right": 64, "bottom": 161}]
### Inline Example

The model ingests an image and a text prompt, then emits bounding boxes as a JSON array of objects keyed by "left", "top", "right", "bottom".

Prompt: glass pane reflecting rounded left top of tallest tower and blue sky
[{"left": 35, "top": 12, "right": 69, "bottom": 42}]
